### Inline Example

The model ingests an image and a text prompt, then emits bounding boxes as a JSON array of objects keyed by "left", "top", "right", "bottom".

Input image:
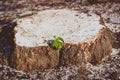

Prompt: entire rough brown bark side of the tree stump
[{"left": 10, "top": 27, "right": 112, "bottom": 72}]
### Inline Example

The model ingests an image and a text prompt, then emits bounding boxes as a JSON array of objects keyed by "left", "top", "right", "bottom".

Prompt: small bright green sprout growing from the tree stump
[{"left": 51, "top": 36, "right": 64, "bottom": 49}]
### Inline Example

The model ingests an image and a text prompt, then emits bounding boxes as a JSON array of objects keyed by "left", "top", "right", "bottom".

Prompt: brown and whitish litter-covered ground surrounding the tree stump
[{"left": 0, "top": 0, "right": 120, "bottom": 80}]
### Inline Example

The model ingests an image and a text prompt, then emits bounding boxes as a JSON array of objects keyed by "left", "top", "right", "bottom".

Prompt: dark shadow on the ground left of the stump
[{"left": 0, "top": 20, "right": 16, "bottom": 65}]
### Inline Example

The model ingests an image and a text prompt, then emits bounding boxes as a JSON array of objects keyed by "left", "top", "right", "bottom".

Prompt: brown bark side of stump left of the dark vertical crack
[{"left": 11, "top": 45, "right": 59, "bottom": 71}]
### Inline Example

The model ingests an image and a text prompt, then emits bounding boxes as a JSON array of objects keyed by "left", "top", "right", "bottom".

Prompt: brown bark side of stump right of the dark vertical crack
[{"left": 60, "top": 28, "right": 112, "bottom": 65}]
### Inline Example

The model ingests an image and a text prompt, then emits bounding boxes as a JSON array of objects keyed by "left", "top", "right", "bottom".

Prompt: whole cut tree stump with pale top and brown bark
[{"left": 10, "top": 9, "right": 112, "bottom": 72}]
